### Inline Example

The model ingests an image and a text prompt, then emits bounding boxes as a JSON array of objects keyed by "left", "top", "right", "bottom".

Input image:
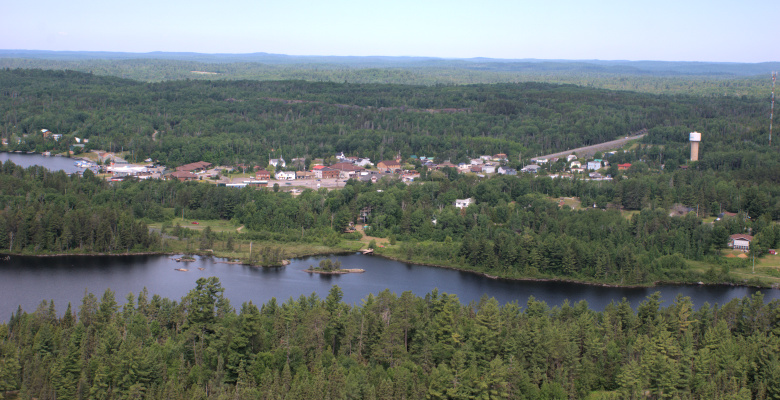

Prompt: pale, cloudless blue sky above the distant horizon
[{"left": 0, "top": 0, "right": 780, "bottom": 63}]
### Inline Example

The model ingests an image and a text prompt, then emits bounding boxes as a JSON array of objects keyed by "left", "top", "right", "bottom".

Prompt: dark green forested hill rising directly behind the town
[{"left": 0, "top": 70, "right": 768, "bottom": 165}]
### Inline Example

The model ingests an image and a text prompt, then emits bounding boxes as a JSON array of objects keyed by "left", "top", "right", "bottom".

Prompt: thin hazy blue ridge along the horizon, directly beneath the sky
[{"left": 0, "top": 50, "right": 780, "bottom": 77}]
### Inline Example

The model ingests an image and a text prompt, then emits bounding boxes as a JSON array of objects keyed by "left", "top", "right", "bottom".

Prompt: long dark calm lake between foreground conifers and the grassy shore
[{"left": 0, "top": 254, "right": 780, "bottom": 321}]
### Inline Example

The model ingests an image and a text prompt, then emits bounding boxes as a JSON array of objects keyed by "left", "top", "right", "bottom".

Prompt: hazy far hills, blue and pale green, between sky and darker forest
[{"left": 0, "top": 50, "right": 780, "bottom": 97}]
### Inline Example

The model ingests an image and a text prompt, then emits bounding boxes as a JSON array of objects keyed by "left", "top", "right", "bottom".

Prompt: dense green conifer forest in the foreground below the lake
[{"left": 0, "top": 278, "right": 780, "bottom": 400}]
